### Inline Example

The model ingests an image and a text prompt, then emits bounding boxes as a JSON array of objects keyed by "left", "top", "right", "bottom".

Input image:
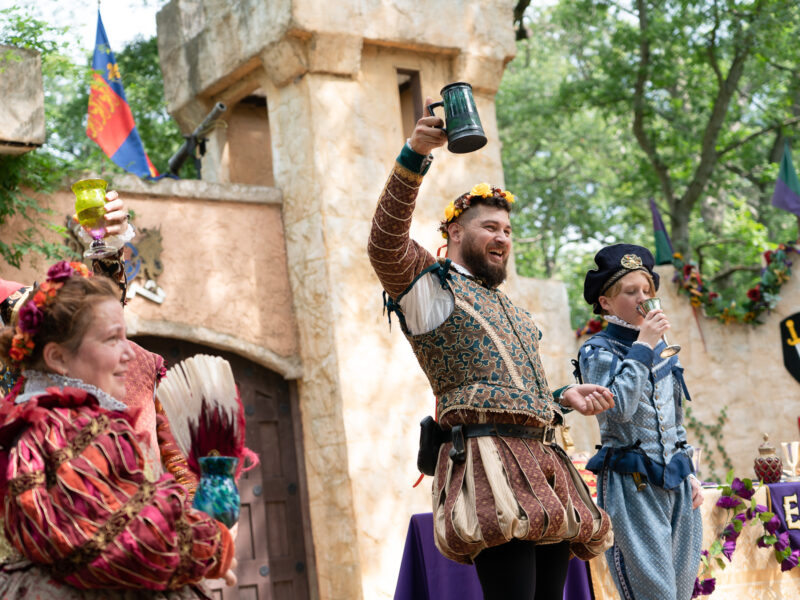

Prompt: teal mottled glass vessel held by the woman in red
[{"left": 192, "top": 456, "right": 240, "bottom": 527}]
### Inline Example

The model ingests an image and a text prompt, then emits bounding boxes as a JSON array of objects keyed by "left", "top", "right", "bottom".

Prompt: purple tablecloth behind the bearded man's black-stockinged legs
[{"left": 394, "top": 513, "right": 592, "bottom": 600}]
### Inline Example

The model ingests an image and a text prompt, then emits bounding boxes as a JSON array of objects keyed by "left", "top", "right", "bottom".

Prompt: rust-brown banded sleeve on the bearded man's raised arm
[{"left": 367, "top": 163, "right": 435, "bottom": 298}]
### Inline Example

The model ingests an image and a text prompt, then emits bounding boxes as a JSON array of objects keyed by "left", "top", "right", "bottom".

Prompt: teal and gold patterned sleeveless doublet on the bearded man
[{"left": 392, "top": 261, "right": 561, "bottom": 424}]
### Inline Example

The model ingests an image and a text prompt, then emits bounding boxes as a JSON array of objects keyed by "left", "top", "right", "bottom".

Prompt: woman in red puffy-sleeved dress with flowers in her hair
[{"left": 0, "top": 261, "right": 235, "bottom": 600}]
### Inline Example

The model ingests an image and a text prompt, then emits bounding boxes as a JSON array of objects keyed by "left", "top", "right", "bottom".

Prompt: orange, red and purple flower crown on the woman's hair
[{"left": 8, "top": 260, "right": 92, "bottom": 366}]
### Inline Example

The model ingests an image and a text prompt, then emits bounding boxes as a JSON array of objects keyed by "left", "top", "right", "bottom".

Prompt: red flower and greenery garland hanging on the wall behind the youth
[{"left": 672, "top": 244, "right": 797, "bottom": 325}]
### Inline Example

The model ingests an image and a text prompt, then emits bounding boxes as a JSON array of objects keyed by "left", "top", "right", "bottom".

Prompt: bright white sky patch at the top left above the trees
[{"left": 0, "top": 0, "right": 167, "bottom": 58}]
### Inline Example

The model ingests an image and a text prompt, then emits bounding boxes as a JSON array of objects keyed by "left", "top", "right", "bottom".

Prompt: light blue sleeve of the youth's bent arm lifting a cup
[{"left": 580, "top": 344, "right": 653, "bottom": 423}]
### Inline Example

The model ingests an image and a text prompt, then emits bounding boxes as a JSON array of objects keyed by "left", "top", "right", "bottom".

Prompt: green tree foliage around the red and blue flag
[{"left": 0, "top": 7, "right": 191, "bottom": 267}]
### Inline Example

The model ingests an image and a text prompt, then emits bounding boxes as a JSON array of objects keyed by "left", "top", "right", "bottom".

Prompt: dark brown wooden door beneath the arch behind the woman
[{"left": 135, "top": 336, "right": 315, "bottom": 600}]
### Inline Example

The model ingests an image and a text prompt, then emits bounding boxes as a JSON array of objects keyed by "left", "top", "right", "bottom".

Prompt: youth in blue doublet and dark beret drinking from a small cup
[{"left": 579, "top": 244, "right": 703, "bottom": 600}]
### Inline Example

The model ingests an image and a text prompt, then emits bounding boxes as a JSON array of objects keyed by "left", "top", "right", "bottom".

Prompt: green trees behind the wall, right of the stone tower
[{"left": 498, "top": 0, "right": 800, "bottom": 321}]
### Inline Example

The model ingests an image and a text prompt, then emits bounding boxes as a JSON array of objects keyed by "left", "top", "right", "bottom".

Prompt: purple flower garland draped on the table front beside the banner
[{"left": 692, "top": 471, "right": 800, "bottom": 598}]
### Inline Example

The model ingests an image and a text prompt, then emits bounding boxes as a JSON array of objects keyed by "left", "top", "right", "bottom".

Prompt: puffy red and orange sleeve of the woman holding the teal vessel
[{"left": 4, "top": 400, "right": 234, "bottom": 590}]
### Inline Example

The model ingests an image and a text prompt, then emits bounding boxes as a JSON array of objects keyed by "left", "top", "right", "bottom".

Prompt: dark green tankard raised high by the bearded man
[{"left": 428, "top": 81, "right": 486, "bottom": 154}]
